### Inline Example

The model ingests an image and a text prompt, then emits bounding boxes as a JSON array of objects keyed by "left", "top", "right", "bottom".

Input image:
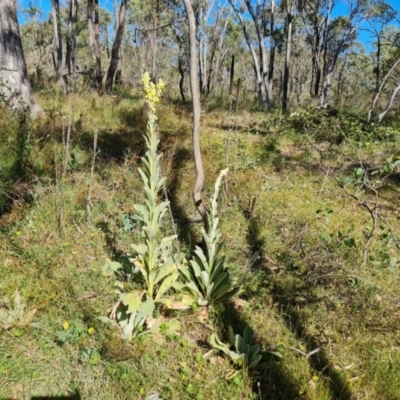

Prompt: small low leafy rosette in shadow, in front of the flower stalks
[{"left": 210, "top": 326, "right": 262, "bottom": 369}]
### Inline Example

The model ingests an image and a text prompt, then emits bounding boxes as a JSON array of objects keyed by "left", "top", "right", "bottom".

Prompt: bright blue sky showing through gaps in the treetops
[{"left": 16, "top": 0, "right": 400, "bottom": 50}]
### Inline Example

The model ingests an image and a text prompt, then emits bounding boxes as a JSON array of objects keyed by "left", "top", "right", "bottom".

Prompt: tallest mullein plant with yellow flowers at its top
[{"left": 117, "top": 72, "right": 179, "bottom": 339}]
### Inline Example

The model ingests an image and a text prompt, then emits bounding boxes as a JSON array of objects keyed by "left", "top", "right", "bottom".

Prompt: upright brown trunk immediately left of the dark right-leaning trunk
[{"left": 87, "top": 0, "right": 103, "bottom": 91}]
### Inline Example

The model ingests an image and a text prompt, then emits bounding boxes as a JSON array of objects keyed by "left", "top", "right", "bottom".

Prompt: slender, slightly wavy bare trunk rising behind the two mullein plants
[{"left": 184, "top": 0, "right": 207, "bottom": 226}]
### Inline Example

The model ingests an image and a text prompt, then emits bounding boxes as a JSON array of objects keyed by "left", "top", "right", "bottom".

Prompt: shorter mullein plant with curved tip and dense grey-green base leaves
[{"left": 179, "top": 169, "right": 240, "bottom": 306}]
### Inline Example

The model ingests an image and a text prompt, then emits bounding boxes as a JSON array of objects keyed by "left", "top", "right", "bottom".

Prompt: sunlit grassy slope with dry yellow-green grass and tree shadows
[{"left": 0, "top": 92, "right": 400, "bottom": 400}]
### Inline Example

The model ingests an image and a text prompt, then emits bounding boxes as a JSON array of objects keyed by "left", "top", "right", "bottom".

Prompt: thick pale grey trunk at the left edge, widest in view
[{"left": 0, "top": 0, "right": 41, "bottom": 113}]
